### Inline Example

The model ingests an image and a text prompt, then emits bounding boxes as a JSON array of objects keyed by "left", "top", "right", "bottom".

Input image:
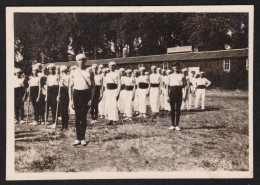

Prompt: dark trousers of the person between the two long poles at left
[{"left": 47, "top": 86, "right": 59, "bottom": 123}]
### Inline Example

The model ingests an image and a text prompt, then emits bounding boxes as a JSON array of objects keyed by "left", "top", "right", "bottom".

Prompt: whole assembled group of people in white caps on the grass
[{"left": 15, "top": 54, "right": 211, "bottom": 145}]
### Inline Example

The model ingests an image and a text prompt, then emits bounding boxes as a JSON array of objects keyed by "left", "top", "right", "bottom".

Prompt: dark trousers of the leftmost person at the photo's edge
[{"left": 14, "top": 87, "right": 24, "bottom": 121}]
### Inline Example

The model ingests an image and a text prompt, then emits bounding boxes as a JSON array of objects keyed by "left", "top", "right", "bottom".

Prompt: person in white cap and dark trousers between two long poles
[{"left": 45, "top": 64, "right": 60, "bottom": 123}]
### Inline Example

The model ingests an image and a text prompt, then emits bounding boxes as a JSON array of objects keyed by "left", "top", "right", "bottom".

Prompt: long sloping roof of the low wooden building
[{"left": 44, "top": 48, "right": 248, "bottom": 66}]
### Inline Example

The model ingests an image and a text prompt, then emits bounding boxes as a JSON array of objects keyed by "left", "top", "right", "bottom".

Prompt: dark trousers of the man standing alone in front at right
[{"left": 169, "top": 86, "right": 182, "bottom": 127}]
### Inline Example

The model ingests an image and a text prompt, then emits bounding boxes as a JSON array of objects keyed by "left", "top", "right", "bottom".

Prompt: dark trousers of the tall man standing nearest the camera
[{"left": 73, "top": 89, "right": 91, "bottom": 141}]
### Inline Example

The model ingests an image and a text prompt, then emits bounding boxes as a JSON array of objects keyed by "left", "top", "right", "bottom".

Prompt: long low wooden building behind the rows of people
[{"left": 48, "top": 48, "right": 249, "bottom": 89}]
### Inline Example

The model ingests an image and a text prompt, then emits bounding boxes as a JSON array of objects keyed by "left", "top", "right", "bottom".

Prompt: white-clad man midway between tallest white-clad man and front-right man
[{"left": 137, "top": 67, "right": 150, "bottom": 118}]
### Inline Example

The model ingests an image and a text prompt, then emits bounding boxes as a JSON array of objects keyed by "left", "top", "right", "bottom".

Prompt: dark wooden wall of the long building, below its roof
[{"left": 117, "top": 58, "right": 248, "bottom": 90}]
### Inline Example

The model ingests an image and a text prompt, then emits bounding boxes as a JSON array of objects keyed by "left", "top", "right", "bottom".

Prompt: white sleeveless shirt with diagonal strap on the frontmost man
[{"left": 71, "top": 68, "right": 91, "bottom": 90}]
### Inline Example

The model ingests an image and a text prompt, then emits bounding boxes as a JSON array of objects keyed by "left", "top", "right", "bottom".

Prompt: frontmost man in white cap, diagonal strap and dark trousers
[{"left": 69, "top": 54, "right": 95, "bottom": 146}]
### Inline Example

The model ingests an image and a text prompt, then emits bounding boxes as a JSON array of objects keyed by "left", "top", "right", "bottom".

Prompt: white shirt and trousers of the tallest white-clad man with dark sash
[{"left": 105, "top": 72, "right": 119, "bottom": 121}]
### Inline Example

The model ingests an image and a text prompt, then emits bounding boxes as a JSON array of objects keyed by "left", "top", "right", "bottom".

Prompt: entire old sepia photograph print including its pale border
[{"left": 6, "top": 5, "right": 254, "bottom": 180}]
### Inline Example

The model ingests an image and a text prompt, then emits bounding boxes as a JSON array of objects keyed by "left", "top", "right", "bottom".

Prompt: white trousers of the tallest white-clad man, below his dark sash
[{"left": 105, "top": 89, "right": 119, "bottom": 121}]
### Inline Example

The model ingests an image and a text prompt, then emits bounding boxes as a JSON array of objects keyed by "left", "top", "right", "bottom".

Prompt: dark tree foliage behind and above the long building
[{"left": 14, "top": 13, "right": 248, "bottom": 71}]
